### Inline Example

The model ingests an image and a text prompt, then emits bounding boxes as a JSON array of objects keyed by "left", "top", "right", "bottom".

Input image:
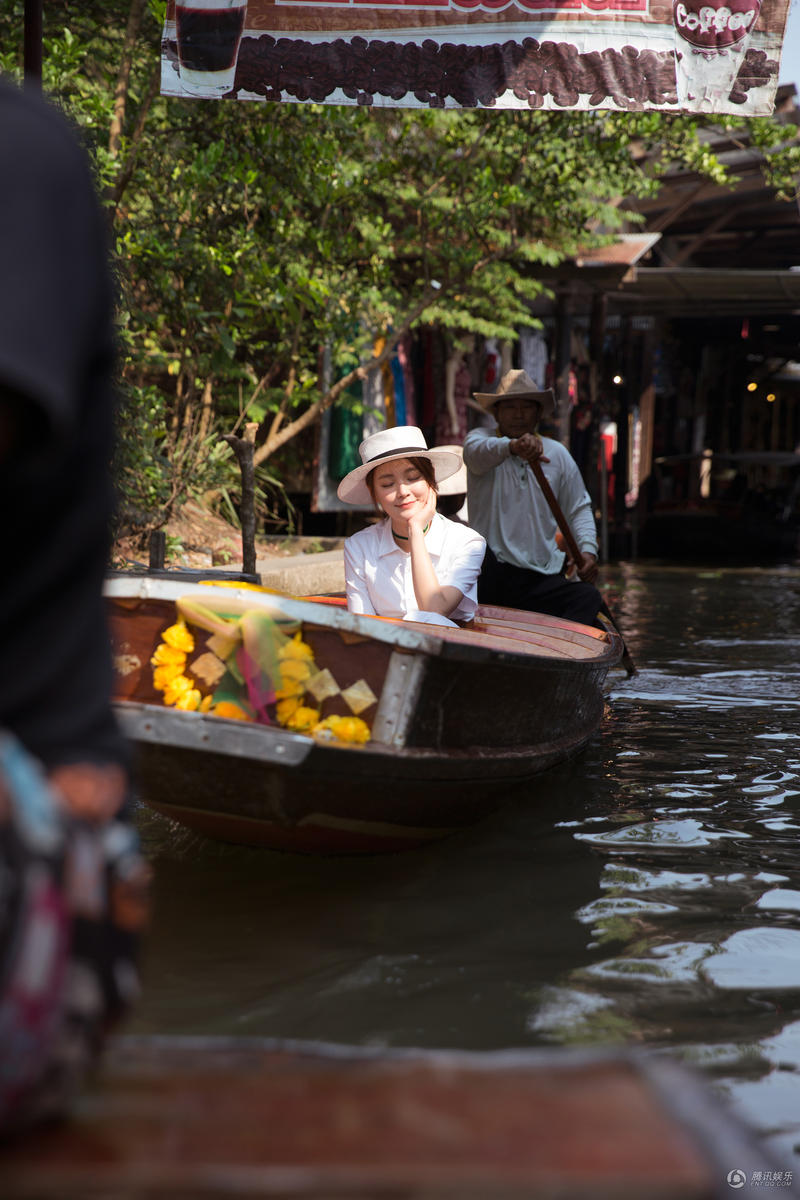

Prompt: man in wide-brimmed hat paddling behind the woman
[{"left": 464, "top": 371, "right": 613, "bottom": 630}]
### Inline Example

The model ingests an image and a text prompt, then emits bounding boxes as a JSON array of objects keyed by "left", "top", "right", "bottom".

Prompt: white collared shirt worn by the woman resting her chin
[{"left": 344, "top": 512, "right": 486, "bottom": 620}]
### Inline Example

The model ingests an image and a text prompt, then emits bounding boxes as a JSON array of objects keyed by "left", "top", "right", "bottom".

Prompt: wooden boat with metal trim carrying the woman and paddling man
[{"left": 106, "top": 576, "right": 622, "bottom": 853}]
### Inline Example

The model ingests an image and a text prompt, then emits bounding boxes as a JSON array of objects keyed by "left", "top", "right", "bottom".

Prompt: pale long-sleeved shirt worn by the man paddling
[{"left": 464, "top": 428, "right": 597, "bottom": 575}]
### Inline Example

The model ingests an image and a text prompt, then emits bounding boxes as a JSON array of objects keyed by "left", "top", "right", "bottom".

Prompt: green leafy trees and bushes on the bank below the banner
[{"left": 0, "top": 0, "right": 800, "bottom": 535}]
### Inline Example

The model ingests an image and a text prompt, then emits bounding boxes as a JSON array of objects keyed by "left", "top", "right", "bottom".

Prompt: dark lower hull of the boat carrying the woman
[{"left": 116, "top": 702, "right": 606, "bottom": 854}]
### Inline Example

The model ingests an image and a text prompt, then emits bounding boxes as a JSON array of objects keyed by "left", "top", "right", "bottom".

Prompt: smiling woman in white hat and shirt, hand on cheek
[{"left": 338, "top": 425, "right": 486, "bottom": 625}]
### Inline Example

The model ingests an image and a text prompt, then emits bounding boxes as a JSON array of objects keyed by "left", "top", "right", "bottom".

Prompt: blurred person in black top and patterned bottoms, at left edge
[{"left": 0, "top": 78, "right": 148, "bottom": 1135}]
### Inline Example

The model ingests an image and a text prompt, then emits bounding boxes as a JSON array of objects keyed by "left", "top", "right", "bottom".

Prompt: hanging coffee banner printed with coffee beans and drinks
[{"left": 161, "top": 0, "right": 790, "bottom": 116}]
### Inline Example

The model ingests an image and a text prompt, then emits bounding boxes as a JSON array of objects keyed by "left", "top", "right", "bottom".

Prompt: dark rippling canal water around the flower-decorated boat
[{"left": 126, "top": 563, "right": 800, "bottom": 1166}]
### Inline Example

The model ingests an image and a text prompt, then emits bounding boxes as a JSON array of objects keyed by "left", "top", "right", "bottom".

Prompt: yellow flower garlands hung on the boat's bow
[{"left": 150, "top": 617, "right": 374, "bottom": 745}]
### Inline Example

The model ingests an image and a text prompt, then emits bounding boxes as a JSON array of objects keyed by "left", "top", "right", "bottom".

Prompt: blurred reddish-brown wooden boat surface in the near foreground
[{"left": 0, "top": 1037, "right": 782, "bottom": 1200}]
